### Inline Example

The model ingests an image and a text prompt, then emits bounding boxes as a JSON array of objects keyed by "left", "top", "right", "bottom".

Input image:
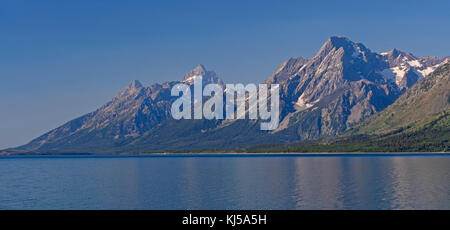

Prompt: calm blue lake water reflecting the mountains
[{"left": 0, "top": 156, "right": 450, "bottom": 209}]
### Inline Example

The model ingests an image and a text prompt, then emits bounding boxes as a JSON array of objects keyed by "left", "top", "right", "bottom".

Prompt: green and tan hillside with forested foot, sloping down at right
[{"left": 251, "top": 63, "right": 450, "bottom": 152}]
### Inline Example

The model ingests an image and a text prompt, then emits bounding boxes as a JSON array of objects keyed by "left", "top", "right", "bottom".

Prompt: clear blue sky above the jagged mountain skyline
[{"left": 0, "top": 0, "right": 450, "bottom": 149}]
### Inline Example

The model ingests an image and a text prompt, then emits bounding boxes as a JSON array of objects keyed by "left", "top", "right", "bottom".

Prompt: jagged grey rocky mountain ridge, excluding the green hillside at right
[{"left": 8, "top": 36, "right": 447, "bottom": 152}]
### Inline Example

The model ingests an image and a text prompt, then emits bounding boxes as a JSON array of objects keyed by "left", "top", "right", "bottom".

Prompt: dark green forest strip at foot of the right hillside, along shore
[{"left": 225, "top": 111, "right": 450, "bottom": 153}]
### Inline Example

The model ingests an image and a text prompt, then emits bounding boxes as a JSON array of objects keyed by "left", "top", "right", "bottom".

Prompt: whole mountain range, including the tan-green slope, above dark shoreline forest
[{"left": 6, "top": 36, "right": 450, "bottom": 153}]
